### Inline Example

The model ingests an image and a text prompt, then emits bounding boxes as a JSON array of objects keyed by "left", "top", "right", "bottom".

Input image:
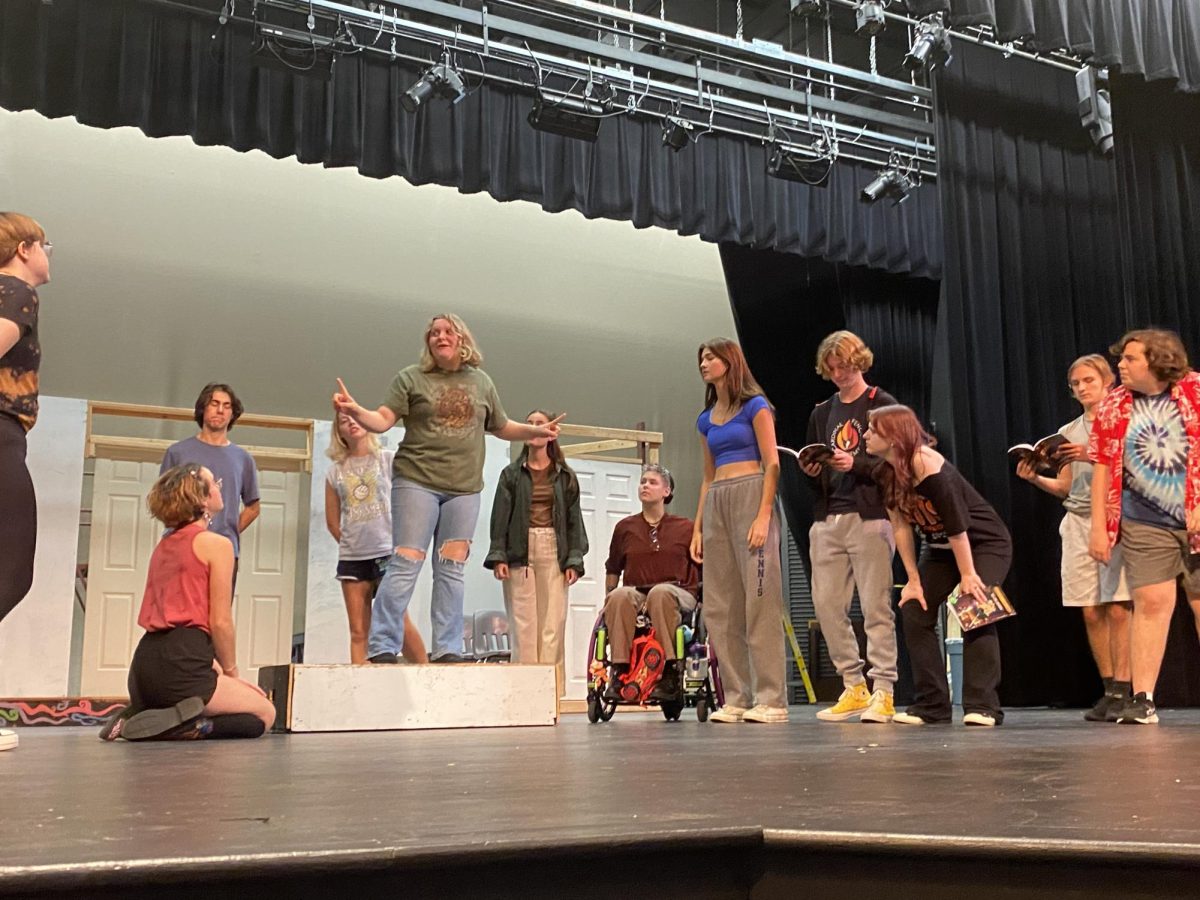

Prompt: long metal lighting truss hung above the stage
[{"left": 187, "top": 0, "right": 937, "bottom": 179}]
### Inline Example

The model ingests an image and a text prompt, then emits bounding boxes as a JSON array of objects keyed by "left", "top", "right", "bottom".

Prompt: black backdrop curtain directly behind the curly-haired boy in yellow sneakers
[{"left": 721, "top": 244, "right": 938, "bottom": 573}]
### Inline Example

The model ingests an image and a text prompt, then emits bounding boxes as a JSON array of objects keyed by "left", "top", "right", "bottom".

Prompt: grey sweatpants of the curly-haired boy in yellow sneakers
[{"left": 809, "top": 512, "right": 896, "bottom": 694}]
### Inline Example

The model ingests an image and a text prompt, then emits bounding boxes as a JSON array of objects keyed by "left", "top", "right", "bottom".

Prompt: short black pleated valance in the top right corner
[{"left": 907, "top": 0, "right": 1200, "bottom": 91}]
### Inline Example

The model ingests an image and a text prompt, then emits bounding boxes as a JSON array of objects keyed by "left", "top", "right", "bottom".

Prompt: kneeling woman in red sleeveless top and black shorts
[{"left": 100, "top": 463, "right": 275, "bottom": 740}]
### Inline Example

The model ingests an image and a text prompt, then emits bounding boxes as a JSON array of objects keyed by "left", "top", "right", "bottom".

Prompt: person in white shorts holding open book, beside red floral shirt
[{"left": 1016, "top": 353, "right": 1130, "bottom": 722}]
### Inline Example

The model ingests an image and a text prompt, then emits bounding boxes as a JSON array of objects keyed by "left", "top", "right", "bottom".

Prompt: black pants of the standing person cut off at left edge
[{"left": 0, "top": 413, "right": 37, "bottom": 620}]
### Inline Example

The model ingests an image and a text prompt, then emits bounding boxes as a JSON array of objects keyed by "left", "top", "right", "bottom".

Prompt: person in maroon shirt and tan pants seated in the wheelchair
[{"left": 604, "top": 463, "right": 700, "bottom": 702}]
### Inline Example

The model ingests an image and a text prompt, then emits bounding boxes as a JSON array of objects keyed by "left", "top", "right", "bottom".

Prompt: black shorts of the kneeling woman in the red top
[{"left": 130, "top": 628, "right": 217, "bottom": 709}]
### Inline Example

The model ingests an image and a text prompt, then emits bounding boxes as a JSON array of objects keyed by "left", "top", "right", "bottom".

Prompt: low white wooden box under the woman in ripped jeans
[{"left": 258, "top": 664, "right": 558, "bottom": 731}]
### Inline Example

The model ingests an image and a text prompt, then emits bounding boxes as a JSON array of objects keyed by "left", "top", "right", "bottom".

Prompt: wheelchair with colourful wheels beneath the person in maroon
[{"left": 588, "top": 602, "right": 725, "bottom": 724}]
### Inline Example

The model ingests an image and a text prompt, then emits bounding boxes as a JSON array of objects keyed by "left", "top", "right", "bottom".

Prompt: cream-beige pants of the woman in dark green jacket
[{"left": 503, "top": 528, "right": 566, "bottom": 696}]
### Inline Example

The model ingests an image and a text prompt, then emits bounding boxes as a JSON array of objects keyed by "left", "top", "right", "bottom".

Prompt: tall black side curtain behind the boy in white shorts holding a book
[{"left": 934, "top": 42, "right": 1127, "bottom": 706}]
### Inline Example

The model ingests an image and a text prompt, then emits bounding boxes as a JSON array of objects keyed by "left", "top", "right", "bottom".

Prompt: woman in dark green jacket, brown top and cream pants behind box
[{"left": 484, "top": 409, "right": 588, "bottom": 696}]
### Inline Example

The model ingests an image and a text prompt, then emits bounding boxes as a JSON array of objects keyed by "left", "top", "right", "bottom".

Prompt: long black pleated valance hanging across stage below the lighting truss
[{"left": 0, "top": 0, "right": 942, "bottom": 276}]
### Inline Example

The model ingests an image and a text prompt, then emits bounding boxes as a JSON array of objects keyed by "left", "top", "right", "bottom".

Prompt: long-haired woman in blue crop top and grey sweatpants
[{"left": 690, "top": 337, "right": 787, "bottom": 724}]
